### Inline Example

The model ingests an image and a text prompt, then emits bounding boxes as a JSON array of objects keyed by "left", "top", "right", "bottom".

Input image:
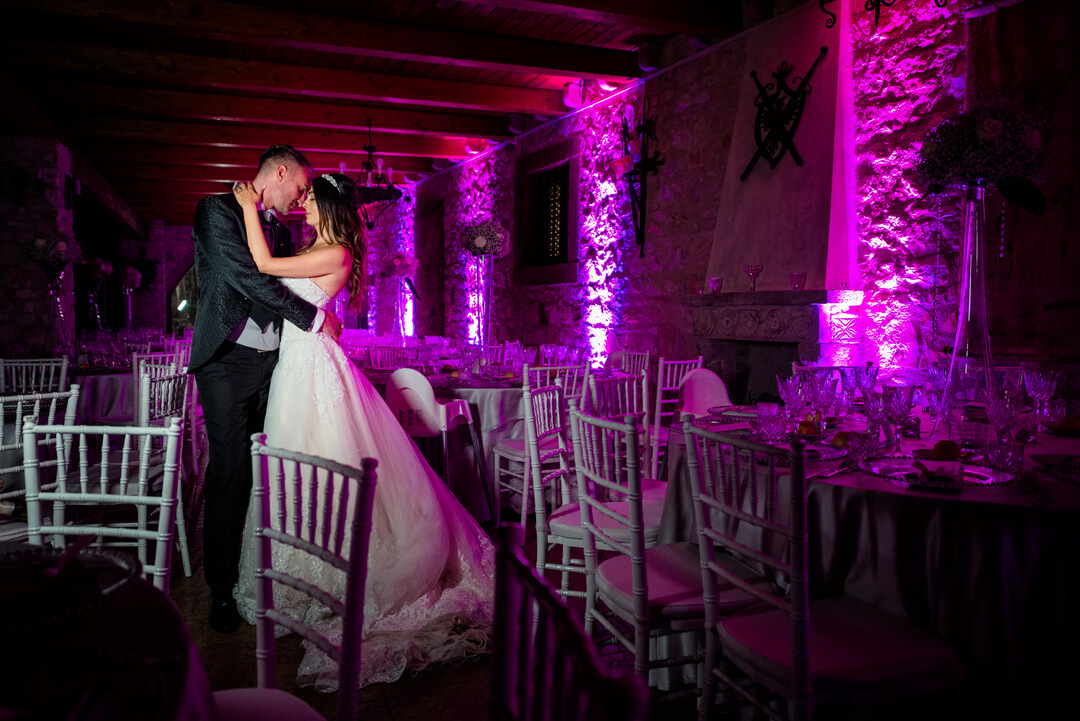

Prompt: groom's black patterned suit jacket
[{"left": 188, "top": 193, "right": 318, "bottom": 372}]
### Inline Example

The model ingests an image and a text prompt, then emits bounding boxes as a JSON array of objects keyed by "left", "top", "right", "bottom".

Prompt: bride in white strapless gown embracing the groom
[{"left": 233, "top": 173, "right": 495, "bottom": 691}]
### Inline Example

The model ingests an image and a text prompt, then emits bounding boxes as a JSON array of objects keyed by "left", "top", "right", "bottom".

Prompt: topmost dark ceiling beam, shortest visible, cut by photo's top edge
[{"left": 469, "top": 0, "right": 742, "bottom": 38}]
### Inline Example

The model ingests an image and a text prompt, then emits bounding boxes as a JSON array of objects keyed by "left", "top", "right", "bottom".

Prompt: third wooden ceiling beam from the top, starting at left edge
[{"left": 14, "top": 39, "right": 566, "bottom": 115}]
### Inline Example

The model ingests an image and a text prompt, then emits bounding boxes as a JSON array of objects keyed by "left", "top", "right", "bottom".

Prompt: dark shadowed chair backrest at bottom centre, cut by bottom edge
[{"left": 489, "top": 525, "right": 648, "bottom": 721}]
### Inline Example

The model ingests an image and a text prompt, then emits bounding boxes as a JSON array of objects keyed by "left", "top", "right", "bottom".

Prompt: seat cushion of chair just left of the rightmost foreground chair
[{"left": 596, "top": 543, "right": 705, "bottom": 627}]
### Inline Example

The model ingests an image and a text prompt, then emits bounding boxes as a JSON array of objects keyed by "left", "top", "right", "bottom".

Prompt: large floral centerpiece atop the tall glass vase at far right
[{"left": 916, "top": 101, "right": 1049, "bottom": 215}]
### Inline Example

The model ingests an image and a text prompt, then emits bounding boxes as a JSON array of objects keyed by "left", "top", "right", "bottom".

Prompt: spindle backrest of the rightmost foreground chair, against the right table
[{"left": 684, "top": 421, "right": 810, "bottom": 718}]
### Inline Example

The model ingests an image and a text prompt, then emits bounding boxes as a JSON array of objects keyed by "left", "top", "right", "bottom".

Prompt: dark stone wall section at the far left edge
[{"left": 0, "top": 137, "right": 75, "bottom": 357}]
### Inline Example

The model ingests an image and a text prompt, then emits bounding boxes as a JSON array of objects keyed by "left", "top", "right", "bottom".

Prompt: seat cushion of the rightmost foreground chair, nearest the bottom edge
[{"left": 717, "top": 597, "right": 963, "bottom": 703}]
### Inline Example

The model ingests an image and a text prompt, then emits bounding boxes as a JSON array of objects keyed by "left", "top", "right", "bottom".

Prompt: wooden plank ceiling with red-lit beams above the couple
[{"left": 0, "top": 0, "right": 742, "bottom": 225}]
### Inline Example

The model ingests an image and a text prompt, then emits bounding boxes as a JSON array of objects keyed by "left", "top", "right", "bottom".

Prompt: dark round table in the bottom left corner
[{"left": 0, "top": 544, "right": 217, "bottom": 721}]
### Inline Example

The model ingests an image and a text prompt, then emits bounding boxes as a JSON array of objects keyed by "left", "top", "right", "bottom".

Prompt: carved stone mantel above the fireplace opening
[{"left": 685, "top": 290, "right": 827, "bottom": 343}]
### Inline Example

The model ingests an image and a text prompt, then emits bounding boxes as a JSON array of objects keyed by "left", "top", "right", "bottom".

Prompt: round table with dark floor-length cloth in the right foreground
[{"left": 660, "top": 410, "right": 1080, "bottom": 694}]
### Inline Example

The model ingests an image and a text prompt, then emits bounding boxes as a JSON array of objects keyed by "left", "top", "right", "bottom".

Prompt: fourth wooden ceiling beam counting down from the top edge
[{"left": 37, "top": 82, "right": 511, "bottom": 140}]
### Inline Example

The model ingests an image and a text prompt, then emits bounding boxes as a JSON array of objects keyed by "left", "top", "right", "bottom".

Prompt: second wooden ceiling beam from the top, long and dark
[{"left": 23, "top": 0, "right": 639, "bottom": 79}]
